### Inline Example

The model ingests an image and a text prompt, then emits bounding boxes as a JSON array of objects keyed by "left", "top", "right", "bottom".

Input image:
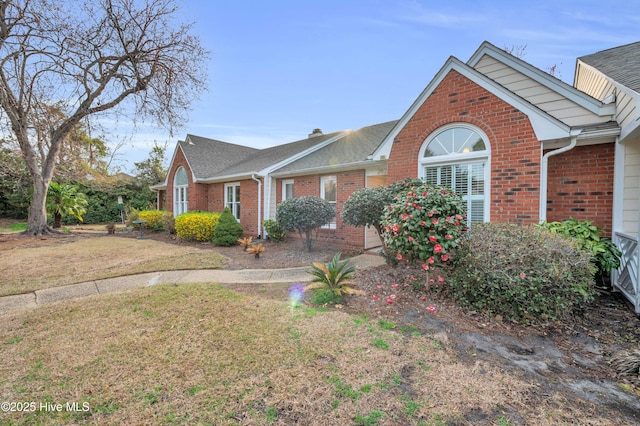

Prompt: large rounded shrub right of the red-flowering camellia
[{"left": 449, "top": 223, "right": 595, "bottom": 323}]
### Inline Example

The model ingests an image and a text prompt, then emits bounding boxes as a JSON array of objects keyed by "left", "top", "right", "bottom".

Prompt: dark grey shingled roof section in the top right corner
[{"left": 578, "top": 41, "right": 640, "bottom": 93}]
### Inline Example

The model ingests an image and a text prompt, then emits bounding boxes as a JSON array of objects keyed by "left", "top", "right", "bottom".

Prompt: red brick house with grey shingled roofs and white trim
[{"left": 155, "top": 42, "right": 640, "bottom": 312}]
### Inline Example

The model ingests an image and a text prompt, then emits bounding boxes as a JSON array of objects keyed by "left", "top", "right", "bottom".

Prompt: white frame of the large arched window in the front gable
[{"left": 418, "top": 123, "right": 491, "bottom": 226}]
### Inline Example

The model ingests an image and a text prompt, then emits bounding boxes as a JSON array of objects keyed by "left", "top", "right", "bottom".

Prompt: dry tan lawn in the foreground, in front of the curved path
[{"left": 0, "top": 284, "right": 632, "bottom": 425}]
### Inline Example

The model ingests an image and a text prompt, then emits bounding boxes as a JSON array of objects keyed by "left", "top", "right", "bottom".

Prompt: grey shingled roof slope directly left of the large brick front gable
[{"left": 272, "top": 120, "right": 398, "bottom": 176}]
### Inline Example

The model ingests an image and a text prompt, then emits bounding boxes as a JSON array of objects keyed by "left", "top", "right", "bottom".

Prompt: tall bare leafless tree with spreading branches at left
[{"left": 0, "top": 0, "right": 208, "bottom": 235}]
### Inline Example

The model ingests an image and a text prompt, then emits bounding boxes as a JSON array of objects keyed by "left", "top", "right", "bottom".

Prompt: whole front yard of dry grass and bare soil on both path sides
[{"left": 0, "top": 228, "right": 640, "bottom": 425}]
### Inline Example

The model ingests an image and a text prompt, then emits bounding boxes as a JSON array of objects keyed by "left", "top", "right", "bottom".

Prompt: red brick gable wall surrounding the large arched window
[{"left": 387, "top": 71, "right": 541, "bottom": 223}]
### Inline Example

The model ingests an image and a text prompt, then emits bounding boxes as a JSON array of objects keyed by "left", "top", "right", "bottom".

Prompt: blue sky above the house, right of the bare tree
[{"left": 120, "top": 0, "right": 640, "bottom": 170}]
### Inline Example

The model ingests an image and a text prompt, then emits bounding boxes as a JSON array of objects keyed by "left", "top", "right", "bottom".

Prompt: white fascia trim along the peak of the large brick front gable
[{"left": 372, "top": 56, "right": 571, "bottom": 160}]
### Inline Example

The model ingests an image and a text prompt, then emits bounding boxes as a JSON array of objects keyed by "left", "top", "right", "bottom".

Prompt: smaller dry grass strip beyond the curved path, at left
[{"left": 0, "top": 235, "right": 224, "bottom": 296}]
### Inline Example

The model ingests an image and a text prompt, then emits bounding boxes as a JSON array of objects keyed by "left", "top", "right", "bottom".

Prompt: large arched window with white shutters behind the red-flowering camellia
[{"left": 418, "top": 123, "right": 491, "bottom": 225}]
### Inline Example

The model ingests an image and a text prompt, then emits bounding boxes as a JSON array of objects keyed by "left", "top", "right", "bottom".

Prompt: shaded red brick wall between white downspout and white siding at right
[{"left": 547, "top": 143, "right": 615, "bottom": 235}]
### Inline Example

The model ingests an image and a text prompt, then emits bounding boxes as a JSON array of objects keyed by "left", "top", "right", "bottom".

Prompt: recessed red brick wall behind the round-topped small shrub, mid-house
[{"left": 276, "top": 170, "right": 365, "bottom": 248}]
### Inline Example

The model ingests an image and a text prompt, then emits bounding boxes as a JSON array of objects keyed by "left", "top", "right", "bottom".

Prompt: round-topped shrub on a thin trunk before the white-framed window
[{"left": 276, "top": 196, "right": 336, "bottom": 251}]
